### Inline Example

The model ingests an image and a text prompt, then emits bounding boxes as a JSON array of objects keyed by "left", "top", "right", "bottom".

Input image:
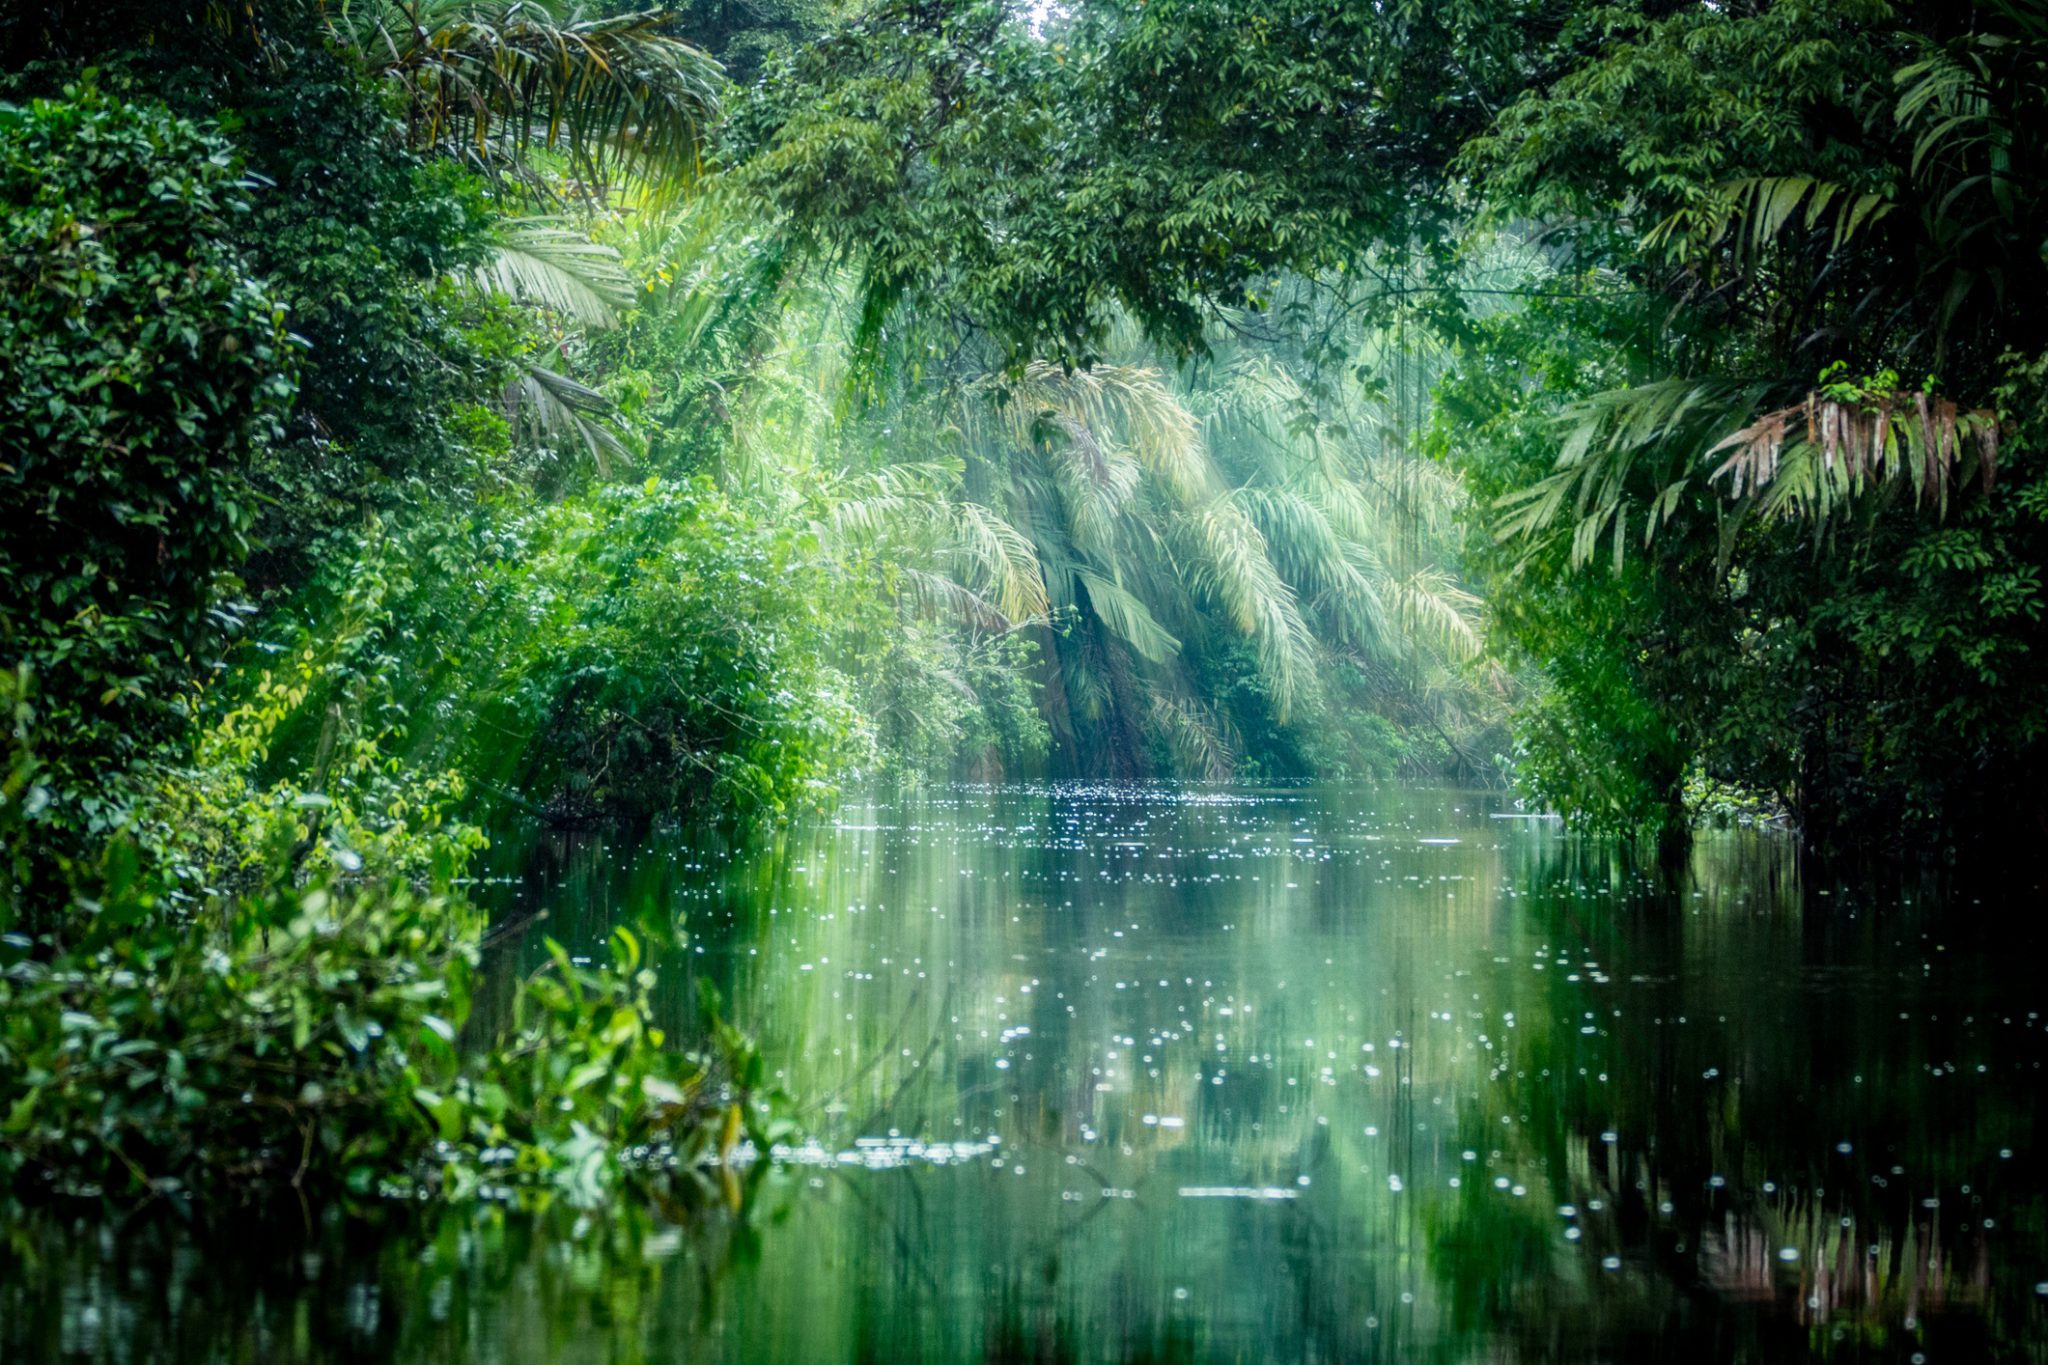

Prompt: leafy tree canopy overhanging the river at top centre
[{"left": 725, "top": 0, "right": 1532, "bottom": 368}]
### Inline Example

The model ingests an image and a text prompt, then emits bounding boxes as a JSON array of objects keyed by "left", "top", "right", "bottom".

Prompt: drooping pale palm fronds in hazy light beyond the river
[{"left": 942, "top": 347, "right": 1479, "bottom": 776}]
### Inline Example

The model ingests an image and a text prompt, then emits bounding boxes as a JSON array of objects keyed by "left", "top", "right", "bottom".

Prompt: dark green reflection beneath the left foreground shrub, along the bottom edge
[{"left": 0, "top": 1203, "right": 750, "bottom": 1365}]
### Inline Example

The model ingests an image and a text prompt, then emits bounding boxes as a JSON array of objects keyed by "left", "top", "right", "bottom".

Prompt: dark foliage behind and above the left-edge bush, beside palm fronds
[{"left": 8, "top": 17, "right": 532, "bottom": 591}]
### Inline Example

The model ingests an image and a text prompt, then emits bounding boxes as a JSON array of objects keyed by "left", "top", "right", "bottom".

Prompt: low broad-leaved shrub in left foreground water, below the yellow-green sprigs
[{"left": 0, "top": 863, "right": 760, "bottom": 1203}]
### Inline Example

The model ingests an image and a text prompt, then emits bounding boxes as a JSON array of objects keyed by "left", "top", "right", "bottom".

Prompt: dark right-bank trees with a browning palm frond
[{"left": 1442, "top": 0, "right": 2048, "bottom": 847}]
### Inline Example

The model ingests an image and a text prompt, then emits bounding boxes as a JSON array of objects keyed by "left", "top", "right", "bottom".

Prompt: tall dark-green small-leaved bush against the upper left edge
[{"left": 0, "top": 86, "right": 293, "bottom": 806}]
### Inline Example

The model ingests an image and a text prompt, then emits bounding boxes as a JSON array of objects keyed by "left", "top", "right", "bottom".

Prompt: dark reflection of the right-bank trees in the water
[{"left": 1432, "top": 826, "right": 2042, "bottom": 1359}]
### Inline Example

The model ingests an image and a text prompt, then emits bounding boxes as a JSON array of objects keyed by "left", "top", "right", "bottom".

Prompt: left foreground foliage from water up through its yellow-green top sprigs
[{"left": 0, "top": 669, "right": 770, "bottom": 1205}]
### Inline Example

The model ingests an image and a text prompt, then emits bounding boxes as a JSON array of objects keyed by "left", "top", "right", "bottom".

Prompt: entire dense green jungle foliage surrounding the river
[{"left": 0, "top": 0, "right": 2048, "bottom": 1197}]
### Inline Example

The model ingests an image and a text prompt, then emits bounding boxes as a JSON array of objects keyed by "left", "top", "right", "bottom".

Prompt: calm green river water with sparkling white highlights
[{"left": 0, "top": 788, "right": 2048, "bottom": 1365}]
